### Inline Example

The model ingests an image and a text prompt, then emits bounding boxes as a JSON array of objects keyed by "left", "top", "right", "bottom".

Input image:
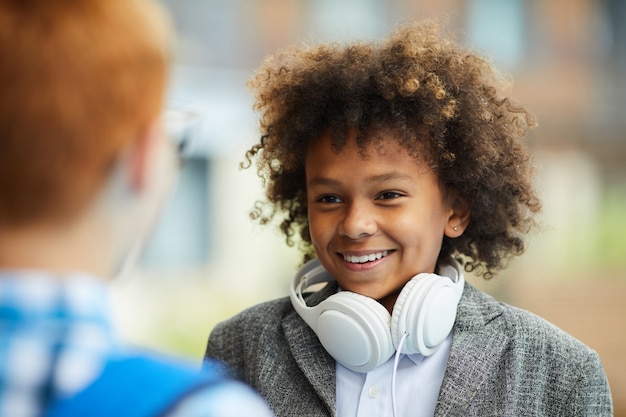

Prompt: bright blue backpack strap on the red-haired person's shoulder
[{"left": 44, "top": 356, "right": 226, "bottom": 417}]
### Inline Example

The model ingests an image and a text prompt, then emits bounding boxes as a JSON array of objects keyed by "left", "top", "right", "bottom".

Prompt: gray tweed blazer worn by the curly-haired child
[{"left": 206, "top": 283, "right": 612, "bottom": 417}]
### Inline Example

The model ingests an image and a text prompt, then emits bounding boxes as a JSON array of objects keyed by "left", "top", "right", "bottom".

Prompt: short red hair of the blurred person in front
[{"left": 0, "top": 0, "right": 169, "bottom": 225}]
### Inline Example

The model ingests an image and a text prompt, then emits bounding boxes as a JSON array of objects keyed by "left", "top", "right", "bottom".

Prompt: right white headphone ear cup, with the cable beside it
[{"left": 391, "top": 274, "right": 458, "bottom": 356}]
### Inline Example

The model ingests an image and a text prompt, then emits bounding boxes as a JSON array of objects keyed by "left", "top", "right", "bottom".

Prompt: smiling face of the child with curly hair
[{"left": 305, "top": 128, "right": 463, "bottom": 311}]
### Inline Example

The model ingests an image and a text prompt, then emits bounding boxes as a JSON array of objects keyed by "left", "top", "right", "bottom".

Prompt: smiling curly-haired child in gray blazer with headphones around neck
[{"left": 206, "top": 23, "right": 612, "bottom": 417}]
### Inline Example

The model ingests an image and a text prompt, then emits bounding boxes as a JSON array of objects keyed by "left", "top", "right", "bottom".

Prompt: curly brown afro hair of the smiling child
[{"left": 243, "top": 22, "right": 541, "bottom": 279}]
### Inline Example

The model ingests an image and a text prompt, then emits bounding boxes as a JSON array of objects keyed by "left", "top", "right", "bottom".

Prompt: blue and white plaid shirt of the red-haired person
[{"left": 0, "top": 271, "right": 271, "bottom": 417}]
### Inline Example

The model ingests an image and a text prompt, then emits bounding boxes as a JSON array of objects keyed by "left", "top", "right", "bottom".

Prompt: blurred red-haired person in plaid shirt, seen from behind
[{"left": 0, "top": 0, "right": 271, "bottom": 417}]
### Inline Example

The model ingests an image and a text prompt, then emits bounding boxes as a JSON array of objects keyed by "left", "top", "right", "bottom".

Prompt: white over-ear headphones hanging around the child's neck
[{"left": 289, "top": 258, "right": 465, "bottom": 372}]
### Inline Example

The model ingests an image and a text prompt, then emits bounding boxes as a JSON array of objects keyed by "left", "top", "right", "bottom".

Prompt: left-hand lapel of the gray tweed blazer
[{"left": 282, "top": 283, "right": 337, "bottom": 415}]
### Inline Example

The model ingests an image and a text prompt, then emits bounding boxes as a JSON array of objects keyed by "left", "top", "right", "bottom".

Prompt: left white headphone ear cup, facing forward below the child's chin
[{"left": 315, "top": 291, "right": 395, "bottom": 372}]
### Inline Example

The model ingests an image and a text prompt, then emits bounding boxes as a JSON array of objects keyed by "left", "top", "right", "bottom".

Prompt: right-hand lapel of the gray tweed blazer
[{"left": 435, "top": 284, "right": 507, "bottom": 416}]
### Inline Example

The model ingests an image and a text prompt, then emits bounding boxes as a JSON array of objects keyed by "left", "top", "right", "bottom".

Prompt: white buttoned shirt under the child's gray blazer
[{"left": 337, "top": 334, "right": 452, "bottom": 417}]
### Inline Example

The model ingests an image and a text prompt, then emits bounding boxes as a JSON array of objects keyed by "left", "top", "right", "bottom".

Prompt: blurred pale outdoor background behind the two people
[{"left": 114, "top": 0, "right": 626, "bottom": 416}]
